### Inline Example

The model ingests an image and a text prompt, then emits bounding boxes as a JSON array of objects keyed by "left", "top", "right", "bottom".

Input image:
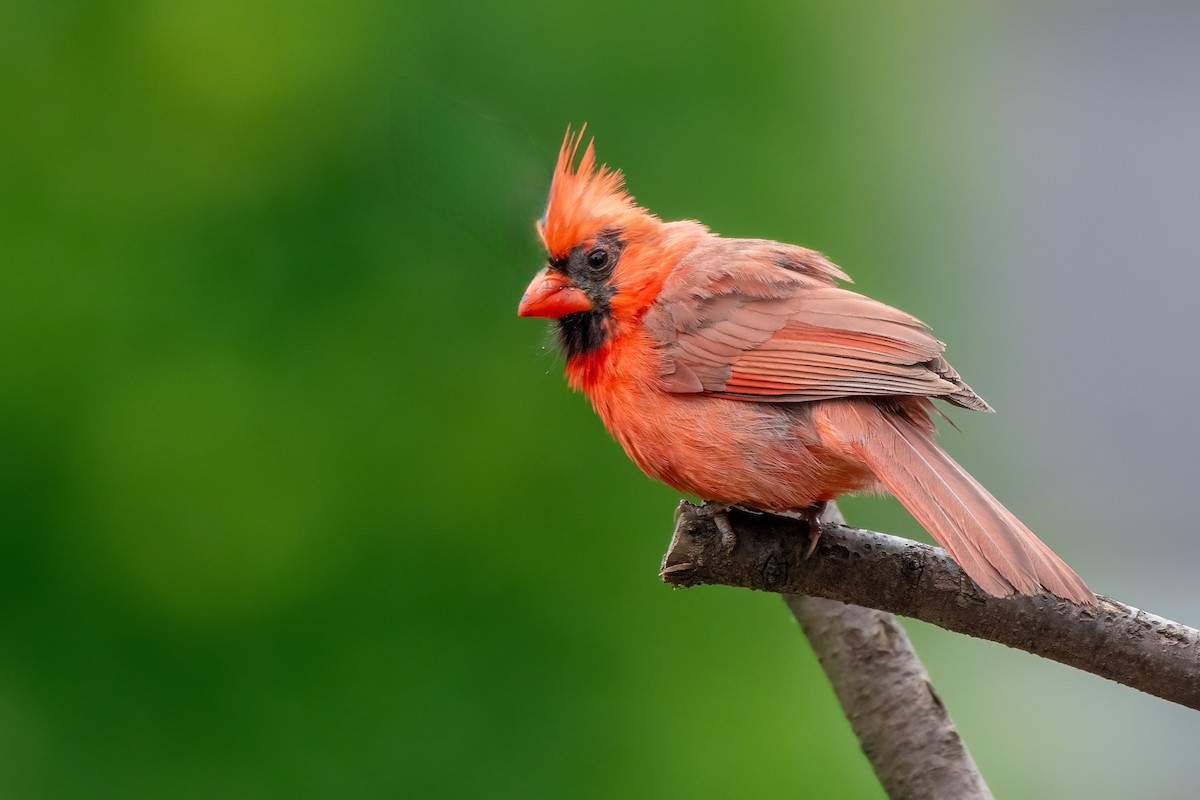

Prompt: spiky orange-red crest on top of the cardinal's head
[{"left": 538, "top": 125, "right": 648, "bottom": 258}]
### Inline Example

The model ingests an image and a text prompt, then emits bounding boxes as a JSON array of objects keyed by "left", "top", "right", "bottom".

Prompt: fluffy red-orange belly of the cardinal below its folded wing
[{"left": 593, "top": 392, "right": 876, "bottom": 511}]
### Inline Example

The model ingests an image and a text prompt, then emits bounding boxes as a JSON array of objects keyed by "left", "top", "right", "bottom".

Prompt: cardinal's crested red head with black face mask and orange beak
[{"left": 517, "top": 128, "right": 664, "bottom": 356}]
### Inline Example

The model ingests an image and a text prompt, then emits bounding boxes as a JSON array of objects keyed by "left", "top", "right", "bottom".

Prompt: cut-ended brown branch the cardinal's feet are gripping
[{"left": 662, "top": 503, "right": 1200, "bottom": 710}]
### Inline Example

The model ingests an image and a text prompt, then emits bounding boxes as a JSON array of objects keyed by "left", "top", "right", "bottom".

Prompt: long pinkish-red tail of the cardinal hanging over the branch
[{"left": 839, "top": 403, "right": 1096, "bottom": 606}]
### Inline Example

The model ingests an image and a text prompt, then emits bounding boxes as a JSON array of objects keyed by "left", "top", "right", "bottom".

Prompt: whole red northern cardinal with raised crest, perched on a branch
[{"left": 517, "top": 128, "right": 1096, "bottom": 604}]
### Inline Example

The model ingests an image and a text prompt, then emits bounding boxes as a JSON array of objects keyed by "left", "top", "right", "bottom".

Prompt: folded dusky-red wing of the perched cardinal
[{"left": 646, "top": 245, "right": 990, "bottom": 410}]
